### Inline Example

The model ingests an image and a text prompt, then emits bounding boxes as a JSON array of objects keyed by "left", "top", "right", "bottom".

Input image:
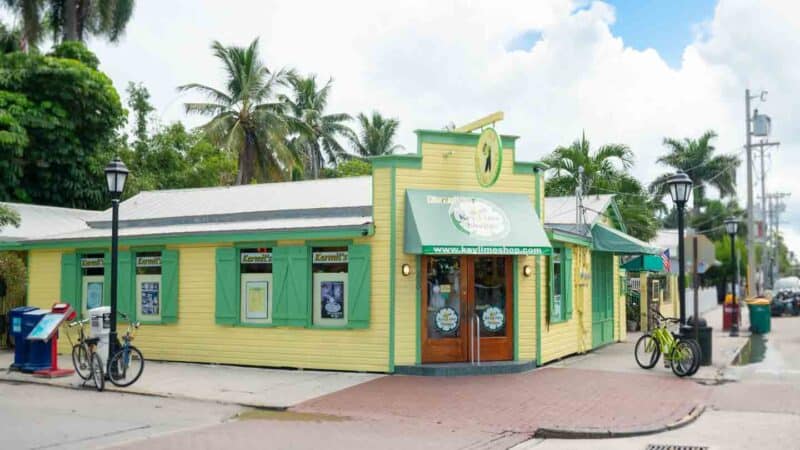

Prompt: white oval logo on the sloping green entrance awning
[{"left": 449, "top": 197, "right": 511, "bottom": 241}]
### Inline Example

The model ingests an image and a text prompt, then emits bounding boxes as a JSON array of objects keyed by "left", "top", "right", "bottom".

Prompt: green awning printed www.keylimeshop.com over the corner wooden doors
[{"left": 403, "top": 189, "right": 552, "bottom": 255}]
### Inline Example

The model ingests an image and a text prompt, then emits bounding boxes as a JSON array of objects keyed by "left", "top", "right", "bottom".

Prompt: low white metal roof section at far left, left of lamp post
[{"left": 0, "top": 203, "right": 102, "bottom": 241}]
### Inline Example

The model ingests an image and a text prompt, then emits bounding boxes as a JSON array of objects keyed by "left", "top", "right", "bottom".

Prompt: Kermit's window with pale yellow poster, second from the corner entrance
[{"left": 239, "top": 248, "right": 273, "bottom": 323}]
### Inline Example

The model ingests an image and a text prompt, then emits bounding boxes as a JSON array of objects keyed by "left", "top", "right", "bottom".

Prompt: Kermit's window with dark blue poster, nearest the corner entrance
[{"left": 311, "top": 247, "right": 348, "bottom": 326}]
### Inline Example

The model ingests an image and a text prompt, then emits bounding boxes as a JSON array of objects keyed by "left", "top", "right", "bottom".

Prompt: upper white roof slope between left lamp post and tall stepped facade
[{"left": 95, "top": 176, "right": 372, "bottom": 222}]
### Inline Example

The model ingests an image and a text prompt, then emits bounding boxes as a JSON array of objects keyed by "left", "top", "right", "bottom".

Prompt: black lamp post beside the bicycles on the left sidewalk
[{"left": 105, "top": 156, "right": 128, "bottom": 361}]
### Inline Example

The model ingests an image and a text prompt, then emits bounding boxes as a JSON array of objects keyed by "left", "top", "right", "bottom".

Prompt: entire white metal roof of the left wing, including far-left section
[{"left": 0, "top": 176, "right": 372, "bottom": 246}]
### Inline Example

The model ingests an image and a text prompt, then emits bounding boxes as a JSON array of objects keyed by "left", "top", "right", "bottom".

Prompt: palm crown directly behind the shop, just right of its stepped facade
[{"left": 543, "top": 133, "right": 633, "bottom": 195}]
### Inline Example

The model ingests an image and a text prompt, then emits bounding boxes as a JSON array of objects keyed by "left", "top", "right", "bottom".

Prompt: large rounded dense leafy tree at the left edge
[{"left": 0, "top": 43, "right": 125, "bottom": 208}]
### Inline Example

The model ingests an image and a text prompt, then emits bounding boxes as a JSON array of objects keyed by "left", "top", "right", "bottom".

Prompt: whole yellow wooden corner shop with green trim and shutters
[{"left": 0, "top": 116, "right": 656, "bottom": 374}]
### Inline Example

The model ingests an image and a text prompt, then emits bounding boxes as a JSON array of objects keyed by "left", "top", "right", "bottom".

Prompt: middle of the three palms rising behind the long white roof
[{"left": 283, "top": 75, "right": 353, "bottom": 178}]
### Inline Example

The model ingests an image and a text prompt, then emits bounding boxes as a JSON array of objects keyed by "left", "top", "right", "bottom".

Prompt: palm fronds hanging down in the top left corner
[{"left": 3, "top": 0, "right": 135, "bottom": 50}]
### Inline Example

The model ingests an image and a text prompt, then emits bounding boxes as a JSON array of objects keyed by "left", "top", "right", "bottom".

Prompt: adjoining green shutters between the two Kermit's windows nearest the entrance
[{"left": 272, "top": 245, "right": 311, "bottom": 327}]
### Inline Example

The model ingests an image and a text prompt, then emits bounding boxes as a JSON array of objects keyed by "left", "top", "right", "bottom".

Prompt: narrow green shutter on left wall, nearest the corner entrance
[{"left": 347, "top": 245, "right": 372, "bottom": 328}]
